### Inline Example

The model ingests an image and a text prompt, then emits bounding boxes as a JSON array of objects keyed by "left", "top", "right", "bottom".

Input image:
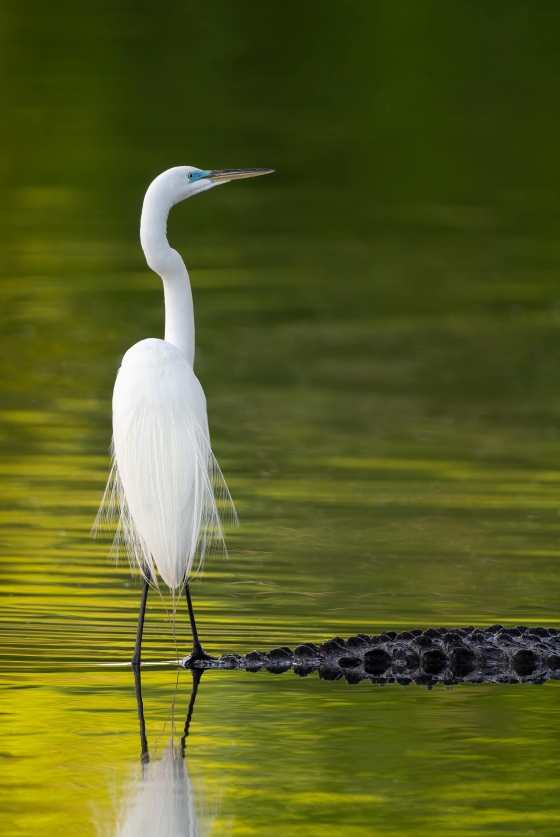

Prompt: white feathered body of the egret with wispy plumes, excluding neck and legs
[{"left": 109, "top": 339, "right": 229, "bottom": 590}]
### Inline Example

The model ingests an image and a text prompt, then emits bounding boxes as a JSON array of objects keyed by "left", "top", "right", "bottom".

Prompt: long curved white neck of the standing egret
[{"left": 140, "top": 183, "right": 194, "bottom": 365}]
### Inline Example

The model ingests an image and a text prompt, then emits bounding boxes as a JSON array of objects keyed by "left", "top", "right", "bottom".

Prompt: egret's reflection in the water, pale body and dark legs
[{"left": 113, "top": 669, "right": 212, "bottom": 837}]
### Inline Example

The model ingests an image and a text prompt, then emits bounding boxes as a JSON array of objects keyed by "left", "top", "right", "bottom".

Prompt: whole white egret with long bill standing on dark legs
[{"left": 98, "top": 166, "right": 274, "bottom": 666}]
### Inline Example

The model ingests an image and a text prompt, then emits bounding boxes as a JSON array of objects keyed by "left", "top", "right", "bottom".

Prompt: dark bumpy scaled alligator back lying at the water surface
[{"left": 184, "top": 625, "right": 560, "bottom": 688}]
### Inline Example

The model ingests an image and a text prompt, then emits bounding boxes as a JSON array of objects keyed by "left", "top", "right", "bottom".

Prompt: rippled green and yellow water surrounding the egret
[{"left": 0, "top": 0, "right": 560, "bottom": 837}]
